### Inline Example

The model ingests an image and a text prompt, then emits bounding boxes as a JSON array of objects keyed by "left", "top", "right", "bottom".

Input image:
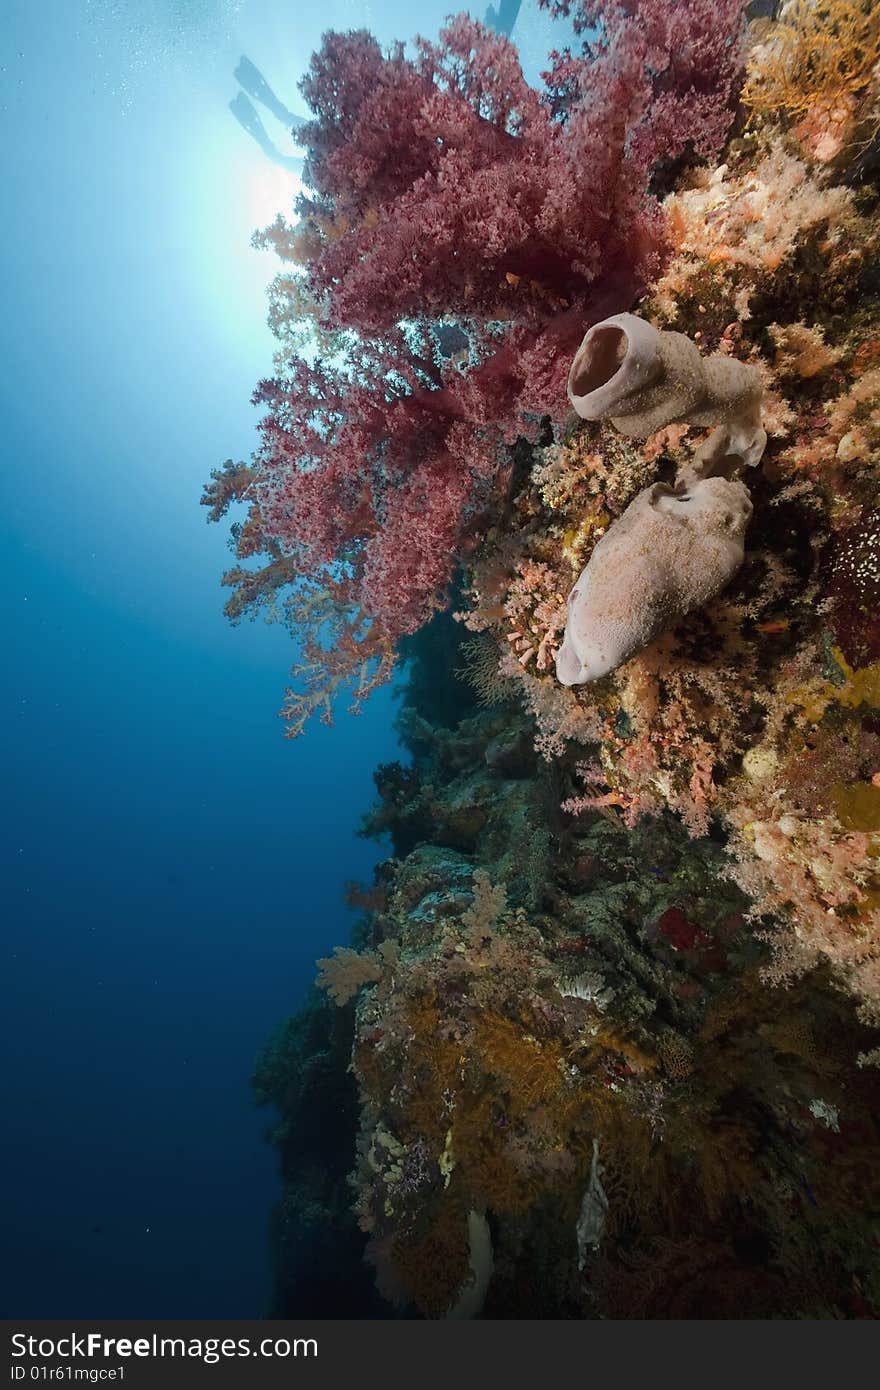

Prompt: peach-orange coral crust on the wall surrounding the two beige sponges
[{"left": 455, "top": 76, "right": 880, "bottom": 1000}]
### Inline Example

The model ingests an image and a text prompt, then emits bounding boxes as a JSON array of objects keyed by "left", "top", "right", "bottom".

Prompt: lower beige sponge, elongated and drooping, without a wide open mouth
[{"left": 556, "top": 480, "right": 752, "bottom": 685}]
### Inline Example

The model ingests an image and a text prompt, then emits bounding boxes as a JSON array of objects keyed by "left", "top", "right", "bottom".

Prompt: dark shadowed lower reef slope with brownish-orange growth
[{"left": 256, "top": 597, "right": 880, "bottom": 1318}]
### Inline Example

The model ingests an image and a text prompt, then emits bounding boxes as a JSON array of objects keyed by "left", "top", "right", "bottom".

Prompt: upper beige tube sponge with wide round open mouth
[{"left": 569, "top": 314, "right": 767, "bottom": 477}]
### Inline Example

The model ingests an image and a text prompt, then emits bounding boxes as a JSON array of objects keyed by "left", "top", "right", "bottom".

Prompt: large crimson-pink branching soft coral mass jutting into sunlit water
[{"left": 206, "top": 0, "right": 742, "bottom": 731}]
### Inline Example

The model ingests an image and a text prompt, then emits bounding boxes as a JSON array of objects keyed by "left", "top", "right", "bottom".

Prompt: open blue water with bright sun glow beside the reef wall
[{"left": 0, "top": 0, "right": 561, "bottom": 1318}]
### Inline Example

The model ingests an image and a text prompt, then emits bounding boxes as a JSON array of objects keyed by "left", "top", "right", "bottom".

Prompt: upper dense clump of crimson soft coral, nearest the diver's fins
[{"left": 300, "top": 4, "right": 741, "bottom": 347}]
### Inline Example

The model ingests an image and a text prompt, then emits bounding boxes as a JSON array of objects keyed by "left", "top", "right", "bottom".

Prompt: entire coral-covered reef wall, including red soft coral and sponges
[{"left": 216, "top": 0, "right": 880, "bottom": 1319}]
